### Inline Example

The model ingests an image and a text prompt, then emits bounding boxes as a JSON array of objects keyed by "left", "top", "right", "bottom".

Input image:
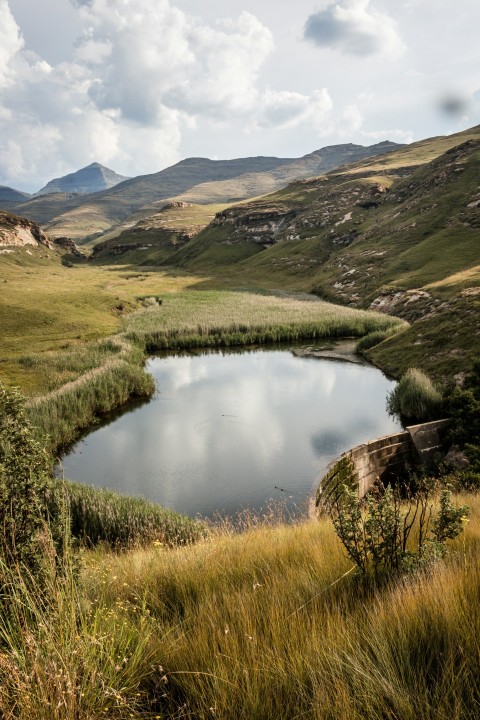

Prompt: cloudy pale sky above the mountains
[{"left": 0, "top": 0, "right": 480, "bottom": 192}]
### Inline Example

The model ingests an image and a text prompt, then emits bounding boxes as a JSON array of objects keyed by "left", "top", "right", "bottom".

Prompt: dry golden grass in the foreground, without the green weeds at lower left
[{"left": 72, "top": 497, "right": 480, "bottom": 720}]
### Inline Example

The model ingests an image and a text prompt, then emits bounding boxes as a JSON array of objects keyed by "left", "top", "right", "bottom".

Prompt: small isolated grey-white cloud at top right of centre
[{"left": 304, "top": 0, "right": 405, "bottom": 57}]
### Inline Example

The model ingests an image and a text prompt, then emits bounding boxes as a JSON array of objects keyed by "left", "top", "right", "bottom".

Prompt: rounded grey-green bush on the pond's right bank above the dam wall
[{"left": 387, "top": 368, "right": 443, "bottom": 422}]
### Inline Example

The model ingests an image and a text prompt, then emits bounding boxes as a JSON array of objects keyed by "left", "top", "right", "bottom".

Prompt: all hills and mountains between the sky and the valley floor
[{"left": 0, "top": 126, "right": 480, "bottom": 380}]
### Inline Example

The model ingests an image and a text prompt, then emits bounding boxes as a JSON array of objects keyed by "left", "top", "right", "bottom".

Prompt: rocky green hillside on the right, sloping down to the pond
[{"left": 162, "top": 128, "right": 480, "bottom": 379}]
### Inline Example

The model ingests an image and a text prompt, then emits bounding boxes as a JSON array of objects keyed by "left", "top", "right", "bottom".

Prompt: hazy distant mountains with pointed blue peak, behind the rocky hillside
[{"left": 1, "top": 142, "right": 402, "bottom": 242}]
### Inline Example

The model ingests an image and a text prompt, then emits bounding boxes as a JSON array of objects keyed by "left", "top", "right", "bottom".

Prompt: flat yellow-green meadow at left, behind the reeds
[{"left": 0, "top": 250, "right": 195, "bottom": 393}]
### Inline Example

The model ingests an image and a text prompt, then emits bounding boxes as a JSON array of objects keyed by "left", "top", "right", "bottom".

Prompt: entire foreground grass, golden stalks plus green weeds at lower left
[{"left": 0, "top": 496, "right": 480, "bottom": 720}]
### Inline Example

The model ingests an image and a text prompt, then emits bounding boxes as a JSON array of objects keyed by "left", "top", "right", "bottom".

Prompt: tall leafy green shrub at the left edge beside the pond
[{"left": 0, "top": 383, "right": 65, "bottom": 582}]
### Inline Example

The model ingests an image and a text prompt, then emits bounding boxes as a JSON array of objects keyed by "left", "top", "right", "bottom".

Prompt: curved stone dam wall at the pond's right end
[{"left": 316, "top": 420, "right": 449, "bottom": 509}]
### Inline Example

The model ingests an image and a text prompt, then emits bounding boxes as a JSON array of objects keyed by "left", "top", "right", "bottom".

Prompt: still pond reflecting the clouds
[{"left": 62, "top": 349, "right": 400, "bottom": 516}]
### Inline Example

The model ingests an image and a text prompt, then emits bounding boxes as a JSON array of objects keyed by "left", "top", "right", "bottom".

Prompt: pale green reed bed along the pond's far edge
[{"left": 125, "top": 291, "right": 405, "bottom": 352}]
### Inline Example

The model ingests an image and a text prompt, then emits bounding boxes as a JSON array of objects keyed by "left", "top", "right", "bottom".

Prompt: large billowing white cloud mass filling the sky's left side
[{"left": 0, "top": 0, "right": 331, "bottom": 189}]
